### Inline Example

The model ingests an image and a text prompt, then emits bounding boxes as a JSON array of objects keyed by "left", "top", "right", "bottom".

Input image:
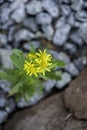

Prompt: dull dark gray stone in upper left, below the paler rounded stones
[{"left": 23, "top": 17, "right": 38, "bottom": 32}]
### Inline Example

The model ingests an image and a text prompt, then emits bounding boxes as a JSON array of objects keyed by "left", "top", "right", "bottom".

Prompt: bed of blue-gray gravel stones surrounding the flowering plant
[{"left": 0, "top": 0, "right": 87, "bottom": 130}]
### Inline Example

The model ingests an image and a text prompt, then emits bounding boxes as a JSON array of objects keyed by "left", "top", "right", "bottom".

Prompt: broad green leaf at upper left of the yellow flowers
[{"left": 11, "top": 49, "right": 25, "bottom": 70}]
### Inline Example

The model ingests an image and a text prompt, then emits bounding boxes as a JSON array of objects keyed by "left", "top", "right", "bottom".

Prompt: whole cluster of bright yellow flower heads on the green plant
[{"left": 23, "top": 49, "right": 52, "bottom": 77}]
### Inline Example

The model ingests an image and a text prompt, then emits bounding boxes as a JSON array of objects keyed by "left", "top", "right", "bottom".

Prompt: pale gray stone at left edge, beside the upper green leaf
[{"left": 0, "top": 49, "right": 13, "bottom": 68}]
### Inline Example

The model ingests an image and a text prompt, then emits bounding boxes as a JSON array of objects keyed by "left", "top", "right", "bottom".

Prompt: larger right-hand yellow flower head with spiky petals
[{"left": 35, "top": 50, "right": 52, "bottom": 75}]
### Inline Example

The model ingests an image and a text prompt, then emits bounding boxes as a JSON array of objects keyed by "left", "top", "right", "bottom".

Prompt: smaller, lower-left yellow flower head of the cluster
[{"left": 24, "top": 61, "right": 38, "bottom": 77}]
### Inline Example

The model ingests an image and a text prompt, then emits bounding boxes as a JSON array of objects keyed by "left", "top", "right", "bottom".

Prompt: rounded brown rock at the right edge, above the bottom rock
[{"left": 64, "top": 68, "right": 87, "bottom": 119}]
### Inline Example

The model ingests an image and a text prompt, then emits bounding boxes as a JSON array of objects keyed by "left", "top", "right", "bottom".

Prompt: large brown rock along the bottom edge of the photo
[{"left": 4, "top": 94, "right": 87, "bottom": 130}]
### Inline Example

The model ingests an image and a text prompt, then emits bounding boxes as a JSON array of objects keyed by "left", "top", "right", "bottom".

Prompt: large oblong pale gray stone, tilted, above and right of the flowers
[{"left": 53, "top": 24, "right": 71, "bottom": 46}]
